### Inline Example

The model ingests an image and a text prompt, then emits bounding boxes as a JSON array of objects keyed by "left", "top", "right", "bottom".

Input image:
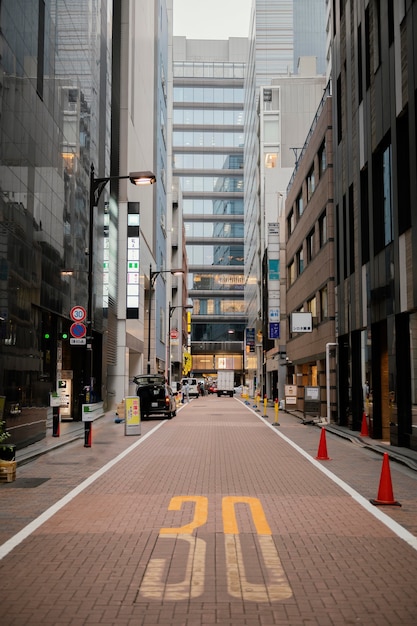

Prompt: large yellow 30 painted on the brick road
[{"left": 139, "top": 496, "right": 292, "bottom": 602}]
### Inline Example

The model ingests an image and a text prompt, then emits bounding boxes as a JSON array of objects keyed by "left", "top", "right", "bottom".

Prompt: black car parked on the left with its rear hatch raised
[{"left": 133, "top": 374, "right": 177, "bottom": 419}]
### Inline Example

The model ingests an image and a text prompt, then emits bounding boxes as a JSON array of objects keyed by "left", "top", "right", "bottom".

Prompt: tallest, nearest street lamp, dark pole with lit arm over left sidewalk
[{"left": 85, "top": 164, "right": 156, "bottom": 401}]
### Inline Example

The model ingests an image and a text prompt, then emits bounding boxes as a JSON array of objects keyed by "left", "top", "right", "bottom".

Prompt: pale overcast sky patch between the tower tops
[{"left": 173, "top": 0, "right": 252, "bottom": 39}]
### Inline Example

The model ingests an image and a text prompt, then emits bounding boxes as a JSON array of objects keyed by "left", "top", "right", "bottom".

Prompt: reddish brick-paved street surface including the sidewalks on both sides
[{"left": 0, "top": 397, "right": 417, "bottom": 626}]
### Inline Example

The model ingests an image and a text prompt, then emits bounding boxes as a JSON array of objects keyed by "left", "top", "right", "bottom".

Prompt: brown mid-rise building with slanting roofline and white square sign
[{"left": 285, "top": 86, "right": 337, "bottom": 421}]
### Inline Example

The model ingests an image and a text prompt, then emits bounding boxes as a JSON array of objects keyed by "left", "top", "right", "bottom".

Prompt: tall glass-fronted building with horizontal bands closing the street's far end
[{"left": 173, "top": 37, "right": 247, "bottom": 382}]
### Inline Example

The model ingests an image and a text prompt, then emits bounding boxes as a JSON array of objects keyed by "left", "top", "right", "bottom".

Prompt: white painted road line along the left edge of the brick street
[{"left": 0, "top": 420, "right": 168, "bottom": 561}]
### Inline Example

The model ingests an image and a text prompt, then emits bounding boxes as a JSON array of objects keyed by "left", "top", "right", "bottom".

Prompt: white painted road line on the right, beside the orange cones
[{"left": 242, "top": 403, "right": 417, "bottom": 550}]
